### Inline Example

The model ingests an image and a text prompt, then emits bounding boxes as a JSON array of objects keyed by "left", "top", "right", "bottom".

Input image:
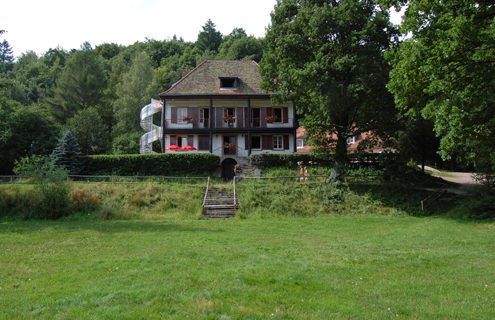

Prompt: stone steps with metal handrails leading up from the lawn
[{"left": 203, "top": 187, "right": 237, "bottom": 219}]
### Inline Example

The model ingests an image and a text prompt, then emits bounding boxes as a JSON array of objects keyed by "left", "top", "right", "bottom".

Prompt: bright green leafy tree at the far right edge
[{"left": 383, "top": 0, "right": 495, "bottom": 174}]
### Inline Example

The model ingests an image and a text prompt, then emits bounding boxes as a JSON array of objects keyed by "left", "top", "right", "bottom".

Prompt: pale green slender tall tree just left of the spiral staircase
[{"left": 113, "top": 52, "right": 153, "bottom": 153}]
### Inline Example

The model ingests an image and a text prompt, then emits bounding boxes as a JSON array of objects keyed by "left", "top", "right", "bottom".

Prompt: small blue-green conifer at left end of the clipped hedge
[{"left": 51, "top": 131, "right": 84, "bottom": 174}]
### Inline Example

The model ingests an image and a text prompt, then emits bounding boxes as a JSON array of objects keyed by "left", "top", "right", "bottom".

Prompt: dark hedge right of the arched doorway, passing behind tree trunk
[{"left": 249, "top": 152, "right": 399, "bottom": 168}]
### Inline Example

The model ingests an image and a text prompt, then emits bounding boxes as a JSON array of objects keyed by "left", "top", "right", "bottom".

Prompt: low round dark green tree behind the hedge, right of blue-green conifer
[{"left": 67, "top": 107, "right": 111, "bottom": 155}]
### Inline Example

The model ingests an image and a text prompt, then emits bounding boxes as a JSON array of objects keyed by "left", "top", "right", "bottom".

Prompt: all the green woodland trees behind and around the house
[{"left": 0, "top": 0, "right": 495, "bottom": 182}]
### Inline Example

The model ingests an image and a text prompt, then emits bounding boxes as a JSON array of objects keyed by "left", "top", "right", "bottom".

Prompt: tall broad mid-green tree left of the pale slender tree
[{"left": 48, "top": 43, "right": 108, "bottom": 123}]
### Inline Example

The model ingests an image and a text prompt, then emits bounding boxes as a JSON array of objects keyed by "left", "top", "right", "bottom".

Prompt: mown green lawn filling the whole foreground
[{"left": 0, "top": 216, "right": 495, "bottom": 319}]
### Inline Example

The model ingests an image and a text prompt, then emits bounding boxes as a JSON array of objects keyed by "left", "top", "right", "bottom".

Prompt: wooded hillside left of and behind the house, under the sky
[{"left": 0, "top": 20, "right": 264, "bottom": 173}]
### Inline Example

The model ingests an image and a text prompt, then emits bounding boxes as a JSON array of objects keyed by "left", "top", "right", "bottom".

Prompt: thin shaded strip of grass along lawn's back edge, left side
[{"left": 0, "top": 220, "right": 225, "bottom": 233}]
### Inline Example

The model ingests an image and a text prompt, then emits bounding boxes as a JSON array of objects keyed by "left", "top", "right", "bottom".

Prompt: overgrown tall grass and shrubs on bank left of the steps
[{"left": 0, "top": 183, "right": 204, "bottom": 220}]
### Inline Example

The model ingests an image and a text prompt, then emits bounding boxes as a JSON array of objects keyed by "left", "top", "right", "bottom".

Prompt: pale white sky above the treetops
[{"left": 0, "top": 0, "right": 400, "bottom": 57}]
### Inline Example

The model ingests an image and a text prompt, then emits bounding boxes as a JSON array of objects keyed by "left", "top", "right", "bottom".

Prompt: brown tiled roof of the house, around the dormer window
[{"left": 160, "top": 60, "right": 268, "bottom": 97}]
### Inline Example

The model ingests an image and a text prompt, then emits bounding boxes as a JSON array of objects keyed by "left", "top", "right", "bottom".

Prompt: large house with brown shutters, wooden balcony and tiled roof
[{"left": 153, "top": 60, "right": 297, "bottom": 163}]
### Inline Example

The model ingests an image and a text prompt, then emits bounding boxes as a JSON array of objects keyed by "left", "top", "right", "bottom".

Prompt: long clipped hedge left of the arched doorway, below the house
[{"left": 82, "top": 153, "right": 220, "bottom": 176}]
